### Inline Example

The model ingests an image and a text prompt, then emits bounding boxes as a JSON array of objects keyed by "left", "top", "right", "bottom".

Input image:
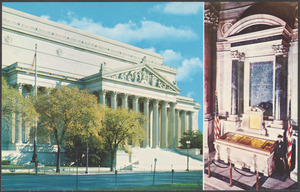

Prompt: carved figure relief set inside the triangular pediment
[{"left": 108, "top": 68, "right": 172, "bottom": 90}]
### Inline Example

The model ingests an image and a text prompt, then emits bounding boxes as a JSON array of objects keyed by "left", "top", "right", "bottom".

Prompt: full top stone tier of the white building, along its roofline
[{"left": 2, "top": 7, "right": 163, "bottom": 65}]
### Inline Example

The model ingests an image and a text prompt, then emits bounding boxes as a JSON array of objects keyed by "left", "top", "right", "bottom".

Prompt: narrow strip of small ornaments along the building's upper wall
[{"left": 2, "top": 16, "right": 161, "bottom": 65}]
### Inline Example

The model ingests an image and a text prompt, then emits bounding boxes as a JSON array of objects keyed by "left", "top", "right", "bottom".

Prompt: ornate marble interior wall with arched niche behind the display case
[{"left": 203, "top": 2, "right": 299, "bottom": 182}]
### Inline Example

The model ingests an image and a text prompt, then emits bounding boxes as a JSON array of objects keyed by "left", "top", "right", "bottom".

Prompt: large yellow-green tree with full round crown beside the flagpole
[{"left": 35, "top": 87, "right": 101, "bottom": 172}]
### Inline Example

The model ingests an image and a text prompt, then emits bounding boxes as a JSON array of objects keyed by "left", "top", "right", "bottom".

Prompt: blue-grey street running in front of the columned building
[{"left": 1, "top": 171, "right": 202, "bottom": 191}]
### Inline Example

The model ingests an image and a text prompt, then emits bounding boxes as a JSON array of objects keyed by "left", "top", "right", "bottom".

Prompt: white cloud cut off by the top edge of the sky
[{"left": 154, "top": 2, "right": 203, "bottom": 15}]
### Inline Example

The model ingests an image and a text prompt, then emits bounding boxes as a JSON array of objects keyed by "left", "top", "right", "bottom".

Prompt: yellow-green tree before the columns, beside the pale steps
[{"left": 101, "top": 107, "right": 146, "bottom": 171}]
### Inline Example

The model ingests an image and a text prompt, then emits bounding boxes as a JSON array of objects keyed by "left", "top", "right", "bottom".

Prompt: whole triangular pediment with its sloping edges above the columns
[{"left": 106, "top": 67, "right": 178, "bottom": 92}]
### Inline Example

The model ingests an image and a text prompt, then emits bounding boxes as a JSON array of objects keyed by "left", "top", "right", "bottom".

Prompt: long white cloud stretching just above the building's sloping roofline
[{"left": 58, "top": 13, "right": 197, "bottom": 43}]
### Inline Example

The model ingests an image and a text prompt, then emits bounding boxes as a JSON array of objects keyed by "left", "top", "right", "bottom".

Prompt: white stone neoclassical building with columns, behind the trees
[{"left": 2, "top": 7, "right": 200, "bottom": 151}]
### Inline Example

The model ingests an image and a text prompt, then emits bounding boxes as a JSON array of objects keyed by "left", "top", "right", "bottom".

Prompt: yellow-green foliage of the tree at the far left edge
[{"left": 1, "top": 77, "right": 39, "bottom": 136}]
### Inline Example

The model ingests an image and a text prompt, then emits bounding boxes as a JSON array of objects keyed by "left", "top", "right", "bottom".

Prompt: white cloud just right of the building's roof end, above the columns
[{"left": 176, "top": 57, "right": 203, "bottom": 81}]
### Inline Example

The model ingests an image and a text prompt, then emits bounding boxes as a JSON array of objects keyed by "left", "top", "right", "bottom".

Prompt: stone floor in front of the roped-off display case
[{"left": 203, "top": 154, "right": 298, "bottom": 190}]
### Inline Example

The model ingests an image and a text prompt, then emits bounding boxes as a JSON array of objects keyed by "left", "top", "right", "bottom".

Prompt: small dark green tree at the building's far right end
[{"left": 179, "top": 130, "right": 203, "bottom": 149}]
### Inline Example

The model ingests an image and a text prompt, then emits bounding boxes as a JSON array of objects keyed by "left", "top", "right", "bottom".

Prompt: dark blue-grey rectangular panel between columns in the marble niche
[{"left": 250, "top": 61, "right": 273, "bottom": 115}]
